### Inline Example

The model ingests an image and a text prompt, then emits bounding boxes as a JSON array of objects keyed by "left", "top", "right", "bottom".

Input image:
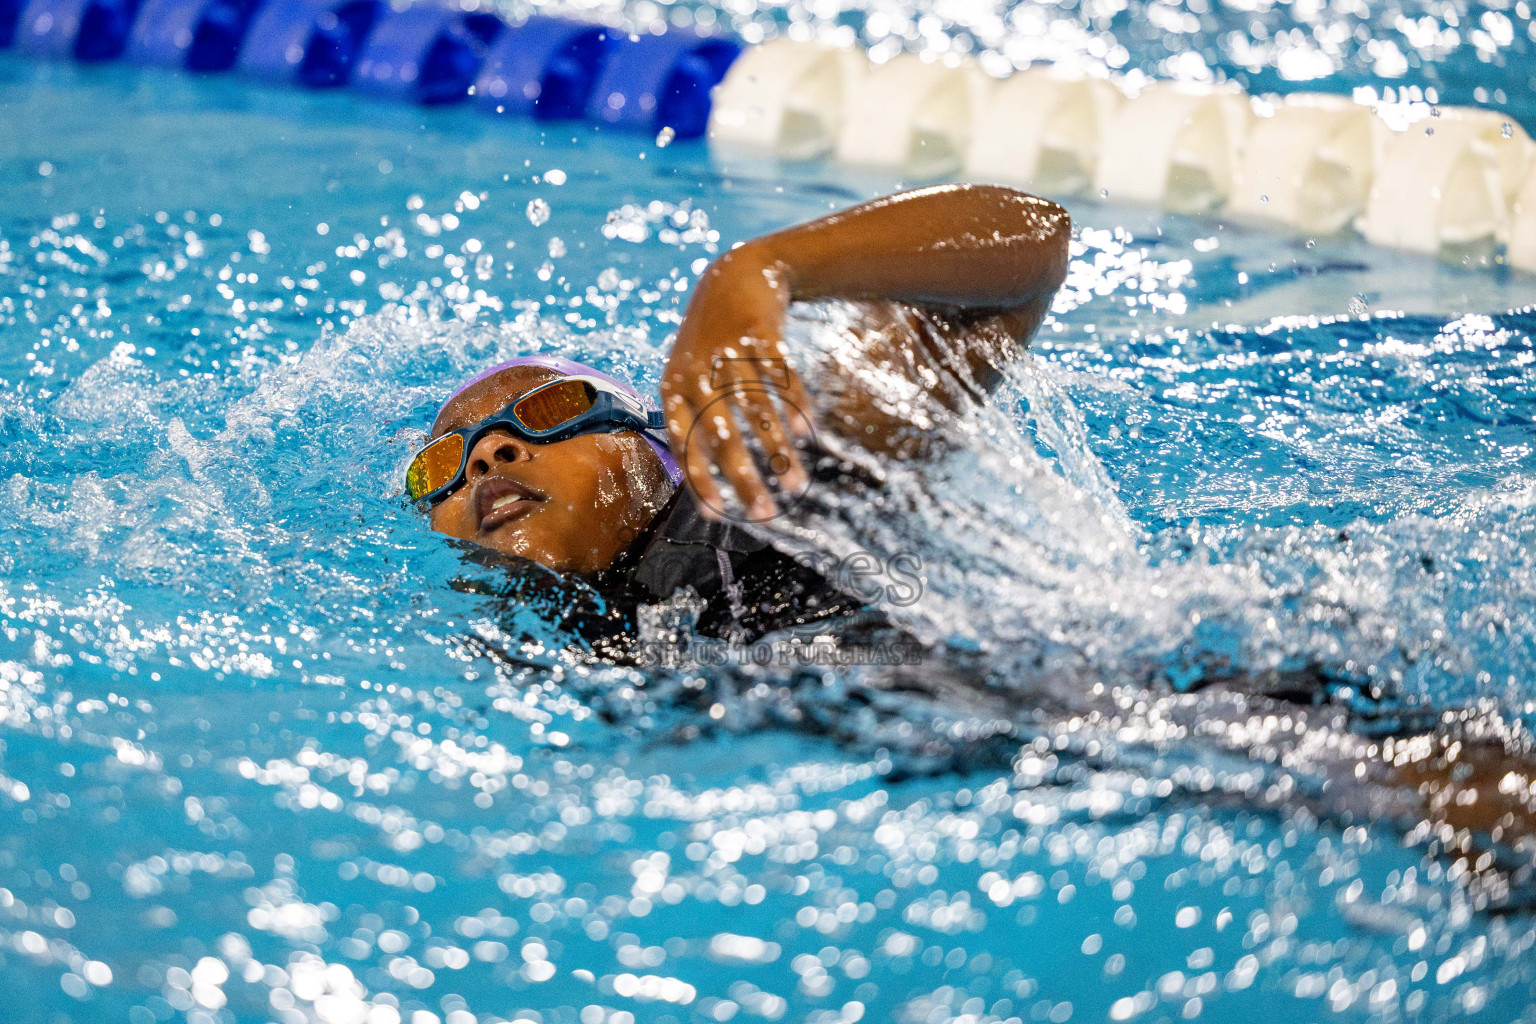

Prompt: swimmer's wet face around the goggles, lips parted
[{"left": 432, "top": 367, "right": 671, "bottom": 573}]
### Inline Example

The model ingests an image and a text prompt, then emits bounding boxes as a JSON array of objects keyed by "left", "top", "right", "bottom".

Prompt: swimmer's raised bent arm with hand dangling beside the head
[{"left": 662, "top": 184, "right": 1071, "bottom": 517}]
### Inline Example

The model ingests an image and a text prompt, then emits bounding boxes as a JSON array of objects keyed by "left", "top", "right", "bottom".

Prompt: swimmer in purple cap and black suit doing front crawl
[{"left": 407, "top": 184, "right": 1536, "bottom": 886}]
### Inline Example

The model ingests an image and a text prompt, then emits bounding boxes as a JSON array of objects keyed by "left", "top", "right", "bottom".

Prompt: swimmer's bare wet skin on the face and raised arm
[{"left": 417, "top": 184, "right": 1071, "bottom": 573}]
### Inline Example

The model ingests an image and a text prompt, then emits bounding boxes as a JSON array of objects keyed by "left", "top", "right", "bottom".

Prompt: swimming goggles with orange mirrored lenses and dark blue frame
[{"left": 406, "top": 376, "right": 665, "bottom": 504}]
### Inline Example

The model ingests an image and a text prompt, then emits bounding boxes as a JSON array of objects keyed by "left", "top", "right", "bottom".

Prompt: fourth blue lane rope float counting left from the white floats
[{"left": 238, "top": 0, "right": 384, "bottom": 89}]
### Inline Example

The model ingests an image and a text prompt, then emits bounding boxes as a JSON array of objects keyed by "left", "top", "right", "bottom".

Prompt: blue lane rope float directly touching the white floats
[{"left": 587, "top": 31, "right": 742, "bottom": 138}]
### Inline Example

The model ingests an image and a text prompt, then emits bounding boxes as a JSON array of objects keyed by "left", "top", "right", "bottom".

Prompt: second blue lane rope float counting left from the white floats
[{"left": 475, "top": 17, "right": 613, "bottom": 121}]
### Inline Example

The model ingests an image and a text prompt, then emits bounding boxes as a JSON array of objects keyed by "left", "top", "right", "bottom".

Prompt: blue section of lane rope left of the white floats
[{"left": 0, "top": 0, "right": 740, "bottom": 138}]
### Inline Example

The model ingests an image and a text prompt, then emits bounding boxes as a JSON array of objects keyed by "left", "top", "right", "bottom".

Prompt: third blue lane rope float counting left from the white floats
[{"left": 352, "top": 5, "right": 502, "bottom": 104}]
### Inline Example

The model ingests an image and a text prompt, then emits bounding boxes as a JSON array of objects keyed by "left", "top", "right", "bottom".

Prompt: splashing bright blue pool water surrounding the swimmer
[{"left": 0, "top": 3, "right": 1536, "bottom": 1024}]
